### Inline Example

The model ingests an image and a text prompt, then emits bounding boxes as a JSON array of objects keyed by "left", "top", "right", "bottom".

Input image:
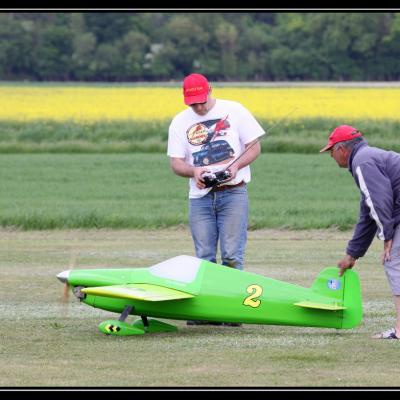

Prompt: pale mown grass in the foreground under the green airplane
[{"left": 0, "top": 227, "right": 399, "bottom": 388}]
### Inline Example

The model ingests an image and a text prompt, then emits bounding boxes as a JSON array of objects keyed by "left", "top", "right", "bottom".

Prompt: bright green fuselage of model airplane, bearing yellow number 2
[{"left": 63, "top": 261, "right": 361, "bottom": 329}]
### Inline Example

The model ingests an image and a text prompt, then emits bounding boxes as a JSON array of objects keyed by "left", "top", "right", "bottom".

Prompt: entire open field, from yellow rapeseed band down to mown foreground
[{"left": 0, "top": 83, "right": 400, "bottom": 388}]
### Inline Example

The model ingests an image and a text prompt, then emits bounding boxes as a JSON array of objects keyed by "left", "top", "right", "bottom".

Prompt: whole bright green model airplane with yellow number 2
[{"left": 57, "top": 255, "right": 362, "bottom": 336}]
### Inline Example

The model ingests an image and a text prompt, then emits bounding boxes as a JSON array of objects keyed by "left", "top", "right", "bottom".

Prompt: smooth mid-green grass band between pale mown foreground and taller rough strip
[{"left": 0, "top": 153, "right": 359, "bottom": 230}]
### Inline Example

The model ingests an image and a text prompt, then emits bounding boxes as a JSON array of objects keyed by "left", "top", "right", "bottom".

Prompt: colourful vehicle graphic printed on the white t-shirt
[{"left": 186, "top": 115, "right": 235, "bottom": 167}]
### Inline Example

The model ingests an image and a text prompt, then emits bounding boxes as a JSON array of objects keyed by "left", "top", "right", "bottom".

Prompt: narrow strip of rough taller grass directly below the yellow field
[{"left": 0, "top": 117, "right": 400, "bottom": 154}]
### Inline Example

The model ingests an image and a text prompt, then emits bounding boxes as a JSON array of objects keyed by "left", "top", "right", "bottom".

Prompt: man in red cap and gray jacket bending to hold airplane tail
[{"left": 320, "top": 125, "right": 400, "bottom": 339}]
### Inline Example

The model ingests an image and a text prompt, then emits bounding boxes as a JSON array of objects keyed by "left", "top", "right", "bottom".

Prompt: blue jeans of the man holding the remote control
[{"left": 189, "top": 186, "right": 248, "bottom": 270}]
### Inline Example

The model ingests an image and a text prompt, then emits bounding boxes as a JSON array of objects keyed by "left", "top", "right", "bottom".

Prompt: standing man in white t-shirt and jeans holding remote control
[{"left": 168, "top": 74, "right": 265, "bottom": 324}]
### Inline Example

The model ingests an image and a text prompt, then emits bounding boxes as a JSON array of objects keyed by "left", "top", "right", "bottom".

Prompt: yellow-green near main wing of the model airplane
[{"left": 81, "top": 283, "right": 194, "bottom": 301}]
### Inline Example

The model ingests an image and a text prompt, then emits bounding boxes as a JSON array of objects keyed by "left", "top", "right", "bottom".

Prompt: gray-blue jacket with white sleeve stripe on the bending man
[{"left": 346, "top": 140, "right": 400, "bottom": 258}]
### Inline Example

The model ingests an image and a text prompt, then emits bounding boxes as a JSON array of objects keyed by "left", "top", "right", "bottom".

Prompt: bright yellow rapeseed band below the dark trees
[{"left": 0, "top": 85, "right": 400, "bottom": 123}]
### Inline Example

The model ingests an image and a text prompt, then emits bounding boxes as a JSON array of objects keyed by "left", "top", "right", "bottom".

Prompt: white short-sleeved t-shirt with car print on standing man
[{"left": 167, "top": 99, "right": 265, "bottom": 199}]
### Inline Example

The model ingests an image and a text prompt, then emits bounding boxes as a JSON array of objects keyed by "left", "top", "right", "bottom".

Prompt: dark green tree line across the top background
[{"left": 0, "top": 11, "right": 400, "bottom": 82}]
